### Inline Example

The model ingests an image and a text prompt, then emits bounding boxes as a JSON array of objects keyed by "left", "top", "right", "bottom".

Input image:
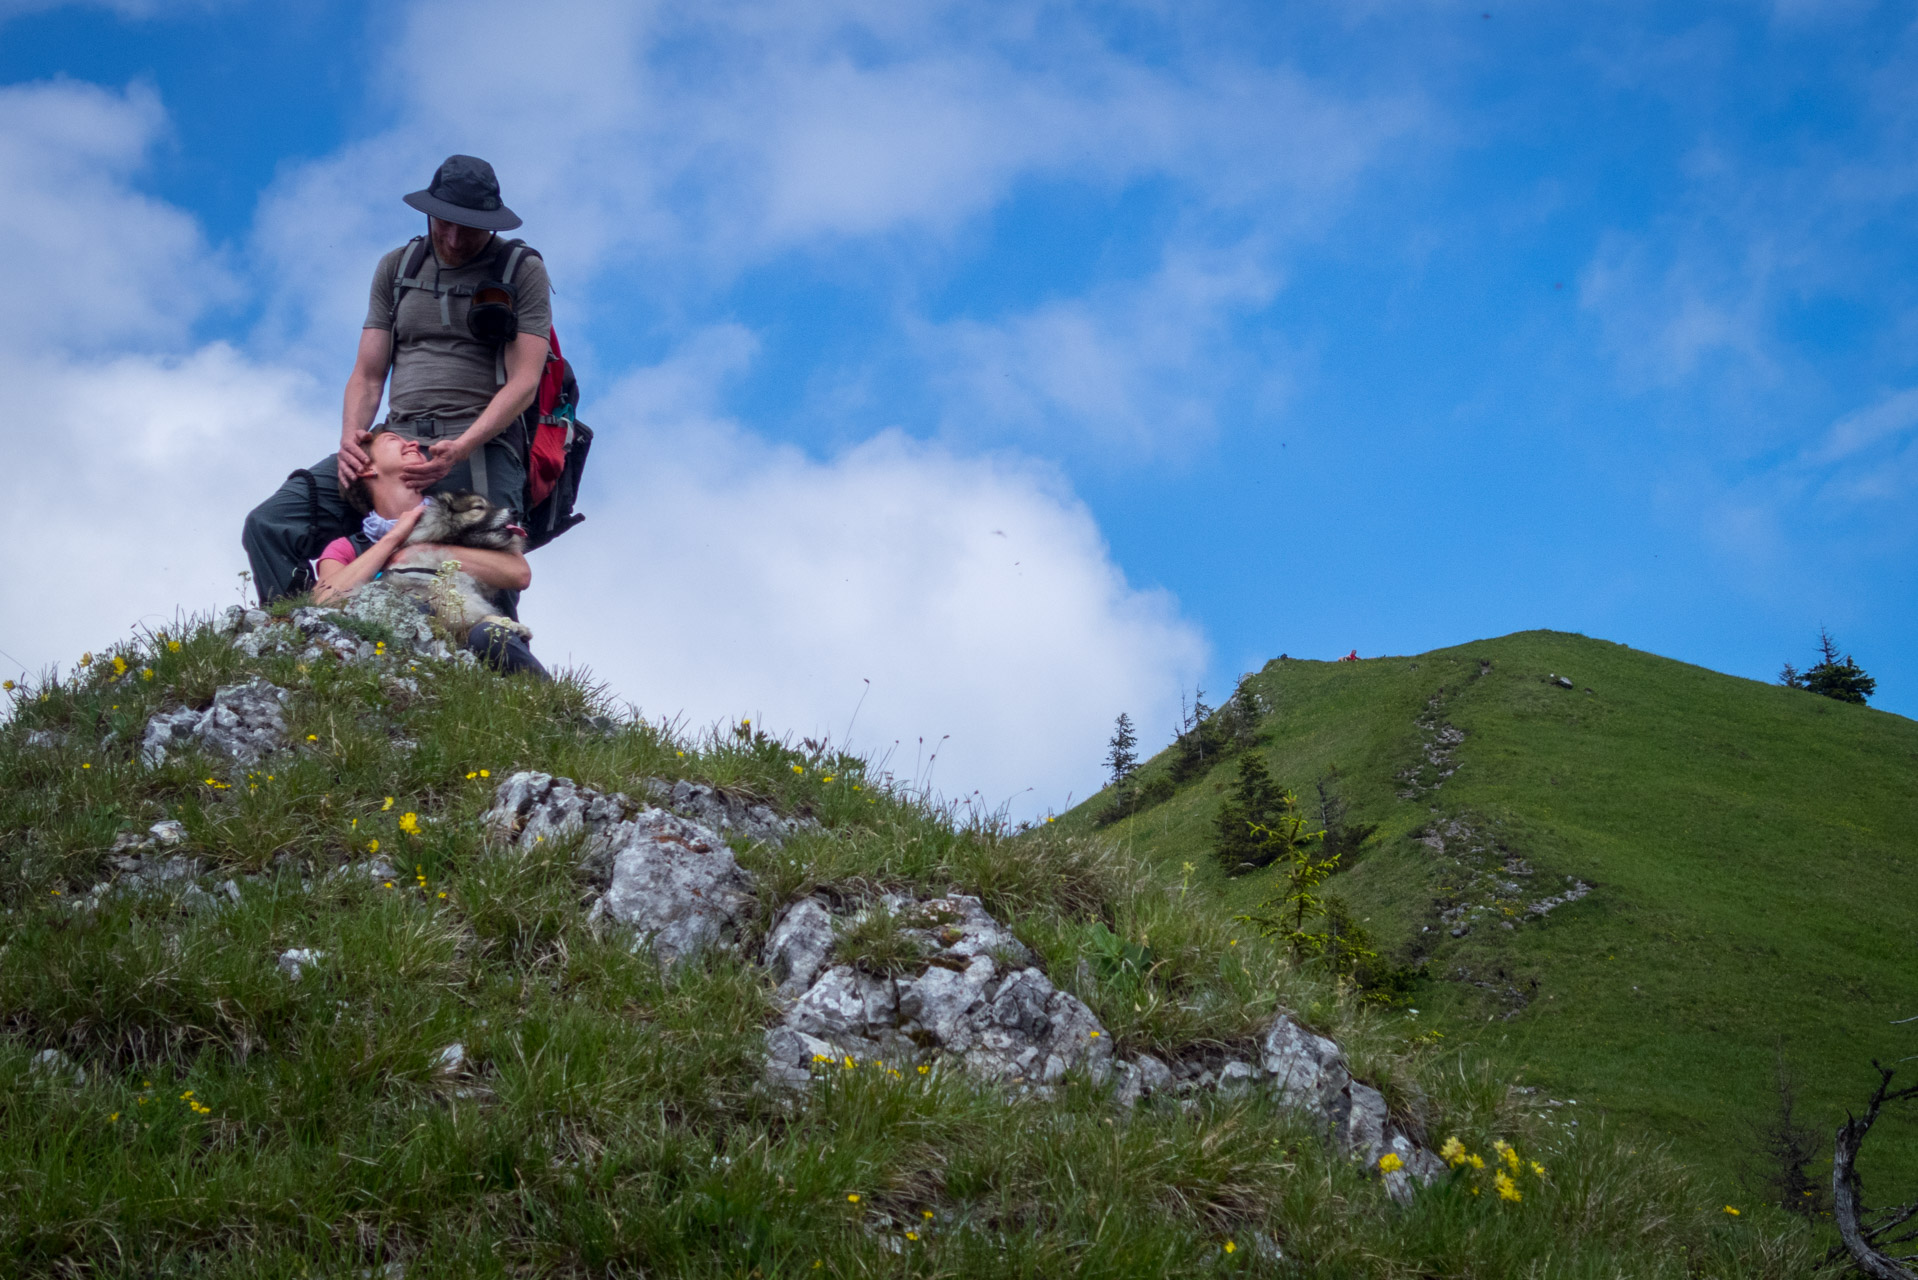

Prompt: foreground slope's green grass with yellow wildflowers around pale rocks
[{"left": 0, "top": 628, "right": 1811, "bottom": 1280}]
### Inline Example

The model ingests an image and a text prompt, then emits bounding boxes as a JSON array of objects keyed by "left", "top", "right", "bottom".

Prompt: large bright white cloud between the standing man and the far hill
[{"left": 526, "top": 332, "right": 1205, "bottom": 814}]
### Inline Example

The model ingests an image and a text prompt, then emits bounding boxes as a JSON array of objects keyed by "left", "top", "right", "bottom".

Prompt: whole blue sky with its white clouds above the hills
[{"left": 0, "top": 0, "right": 1918, "bottom": 812}]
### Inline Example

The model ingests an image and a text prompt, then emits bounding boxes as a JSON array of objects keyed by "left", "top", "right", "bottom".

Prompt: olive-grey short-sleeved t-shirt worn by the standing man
[{"left": 364, "top": 238, "right": 552, "bottom": 422}]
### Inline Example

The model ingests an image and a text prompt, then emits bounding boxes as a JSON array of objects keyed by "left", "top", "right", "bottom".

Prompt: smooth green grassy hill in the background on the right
[{"left": 1061, "top": 631, "right": 1918, "bottom": 1197}]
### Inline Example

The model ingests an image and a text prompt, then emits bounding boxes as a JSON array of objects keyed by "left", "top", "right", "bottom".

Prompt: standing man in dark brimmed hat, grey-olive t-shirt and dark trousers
[{"left": 240, "top": 155, "right": 552, "bottom": 612}]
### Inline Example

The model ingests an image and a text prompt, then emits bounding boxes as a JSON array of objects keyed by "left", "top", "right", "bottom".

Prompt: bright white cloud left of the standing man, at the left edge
[{"left": 0, "top": 345, "right": 334, "bottom": 672}]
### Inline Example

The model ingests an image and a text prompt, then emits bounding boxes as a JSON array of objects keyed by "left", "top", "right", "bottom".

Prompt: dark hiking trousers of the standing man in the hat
[{"left": 251, "top": 418, "right": 526, "bottom": 618}]
